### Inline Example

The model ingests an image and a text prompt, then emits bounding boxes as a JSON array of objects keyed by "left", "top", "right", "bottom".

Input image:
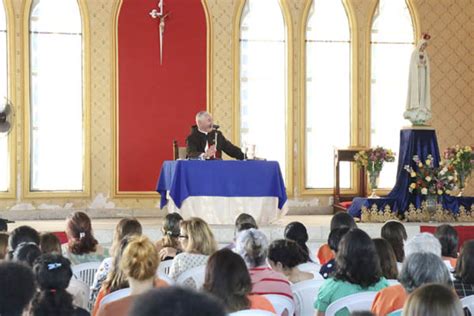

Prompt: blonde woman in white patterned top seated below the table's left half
[{"left": 170, "top": 217, "right": 217, "bottom": 287}]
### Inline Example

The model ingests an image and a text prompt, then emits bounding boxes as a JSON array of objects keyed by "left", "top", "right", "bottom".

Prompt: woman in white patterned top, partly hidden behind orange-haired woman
[{"left": 90, "top": 218, "right": 142, "bottom": 302}]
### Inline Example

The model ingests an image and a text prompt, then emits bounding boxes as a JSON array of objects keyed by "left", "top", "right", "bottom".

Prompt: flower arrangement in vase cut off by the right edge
[{"left": 443, "top": 145, "right": 474, "bottom": 195}]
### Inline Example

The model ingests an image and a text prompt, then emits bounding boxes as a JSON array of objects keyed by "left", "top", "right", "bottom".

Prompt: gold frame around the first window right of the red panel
[{"left": 232, "top": 0, "right": 294, "bottom": 197}]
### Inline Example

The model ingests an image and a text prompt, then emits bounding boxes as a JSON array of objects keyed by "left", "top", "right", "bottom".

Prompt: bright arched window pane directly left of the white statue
[{"left": 370, "top": 0, "right": 414, "bottom": 189}]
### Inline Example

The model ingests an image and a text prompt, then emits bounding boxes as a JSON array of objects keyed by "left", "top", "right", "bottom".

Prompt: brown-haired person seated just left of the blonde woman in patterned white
[{"left": 156, "top": 213, "right": 183, "bottom": 261}]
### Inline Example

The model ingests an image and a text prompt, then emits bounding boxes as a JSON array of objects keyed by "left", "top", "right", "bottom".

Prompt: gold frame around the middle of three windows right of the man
[{"left": 298, "top": 0, "right": 360, "bottom": 196}]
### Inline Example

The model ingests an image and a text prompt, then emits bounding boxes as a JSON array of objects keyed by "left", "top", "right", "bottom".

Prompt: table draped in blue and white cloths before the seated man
[{"left": 156, "top": 160, "right": 287, "bottom": 224}]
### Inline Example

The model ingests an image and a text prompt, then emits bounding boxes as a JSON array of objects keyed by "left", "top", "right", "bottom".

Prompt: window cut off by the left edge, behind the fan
[{"left": 0, "top": 1, "right": 10, "bottom": 192}]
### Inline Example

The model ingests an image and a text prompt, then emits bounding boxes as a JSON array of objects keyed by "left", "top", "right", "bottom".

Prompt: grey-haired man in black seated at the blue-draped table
[{"left": 186, "top": 111, "right": 244, "bottom": 160}]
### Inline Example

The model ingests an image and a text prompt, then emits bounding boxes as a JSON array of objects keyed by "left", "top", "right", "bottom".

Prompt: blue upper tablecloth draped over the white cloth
[{"left": 156, "top": 160, "right": 287, "bottom": 209}]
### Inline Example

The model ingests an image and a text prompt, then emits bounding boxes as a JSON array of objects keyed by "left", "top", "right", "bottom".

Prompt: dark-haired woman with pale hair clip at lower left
[{"left": 30, "top": 254, "right": 89, "bottom": 316}]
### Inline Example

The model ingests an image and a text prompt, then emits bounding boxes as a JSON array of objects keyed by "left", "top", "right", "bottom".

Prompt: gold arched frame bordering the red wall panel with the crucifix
[{"left": 111, "top": 0, "right": 213, "bottom": 199}]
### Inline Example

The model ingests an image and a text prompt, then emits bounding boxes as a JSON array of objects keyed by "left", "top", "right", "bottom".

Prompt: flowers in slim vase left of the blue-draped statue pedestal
[{"left": 354, "top": 147, "right": 395, "bottom": 197}]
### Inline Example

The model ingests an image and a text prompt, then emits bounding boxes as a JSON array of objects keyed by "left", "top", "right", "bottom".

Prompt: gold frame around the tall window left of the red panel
[{"left": 22, "top": 0, "right": 91, "bottom": 198}]
